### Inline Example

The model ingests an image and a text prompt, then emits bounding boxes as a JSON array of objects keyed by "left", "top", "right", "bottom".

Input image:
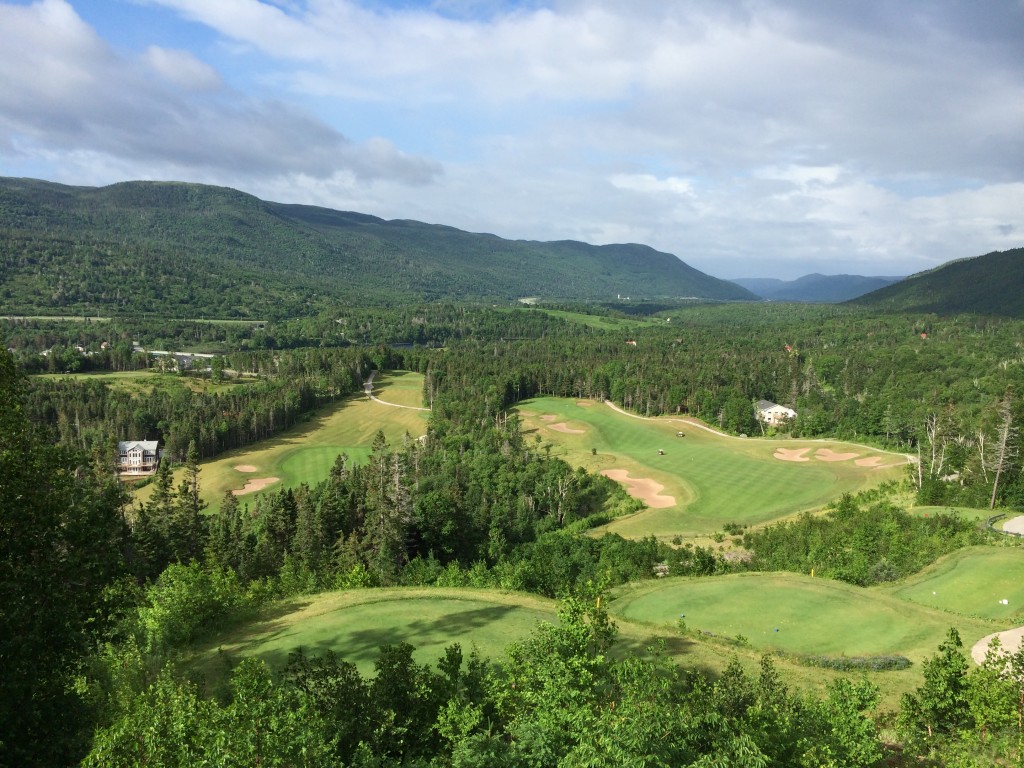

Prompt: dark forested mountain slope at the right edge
[{"left": 853, "top": 248, "right": 1024, "bottom": 317}]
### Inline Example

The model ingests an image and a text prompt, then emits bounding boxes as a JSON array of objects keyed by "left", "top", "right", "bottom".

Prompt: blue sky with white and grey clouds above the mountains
[{"left": 0, "top": 0, "right": 1024, "bottom": 280}]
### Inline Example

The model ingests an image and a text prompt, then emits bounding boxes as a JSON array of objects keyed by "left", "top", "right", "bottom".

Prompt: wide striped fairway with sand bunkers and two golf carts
[{"left": 519, "top": 397, "right": 906, "bottom": 539}]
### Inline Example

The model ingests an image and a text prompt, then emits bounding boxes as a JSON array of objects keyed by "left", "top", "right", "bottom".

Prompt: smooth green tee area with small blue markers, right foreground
[{"left": 609, "top": 573, "right": 1005, "bottom": 663}]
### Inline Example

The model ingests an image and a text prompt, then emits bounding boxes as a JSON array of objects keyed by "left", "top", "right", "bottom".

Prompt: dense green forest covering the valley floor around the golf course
[{"left": 0, "top": 290, "right": 1024, "bottom": 766}]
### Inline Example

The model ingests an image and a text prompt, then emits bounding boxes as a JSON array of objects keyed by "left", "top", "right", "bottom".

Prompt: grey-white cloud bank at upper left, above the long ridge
[{"left": 0, "top": 0, "right": 439, "bottom": 184}]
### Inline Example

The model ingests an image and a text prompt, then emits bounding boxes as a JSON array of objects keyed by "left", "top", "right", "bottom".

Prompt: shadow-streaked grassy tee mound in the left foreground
[{"left": 195, "top": 588, "right": 557, "bottom": 675}]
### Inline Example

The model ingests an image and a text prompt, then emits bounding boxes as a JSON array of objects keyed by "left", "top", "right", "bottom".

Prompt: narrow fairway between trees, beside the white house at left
[{"left": 137, "top": 372, "right": 429, "bottom": 509}]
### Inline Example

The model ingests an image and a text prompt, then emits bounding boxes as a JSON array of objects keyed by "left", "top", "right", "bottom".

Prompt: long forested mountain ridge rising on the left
[{"left": 0, "top": 178, "right": 754, "bottom": 317}]
